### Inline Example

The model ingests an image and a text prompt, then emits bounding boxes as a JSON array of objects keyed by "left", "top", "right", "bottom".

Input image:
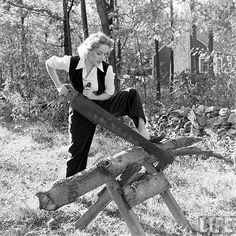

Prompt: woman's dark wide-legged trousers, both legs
[{"left": 66, "top": 89, "right": 146, "bottom": 177}]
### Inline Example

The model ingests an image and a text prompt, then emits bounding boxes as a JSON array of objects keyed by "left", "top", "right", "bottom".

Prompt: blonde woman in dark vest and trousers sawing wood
[{"left": 46, "top": 32, "right": 150, "bottom": 177}]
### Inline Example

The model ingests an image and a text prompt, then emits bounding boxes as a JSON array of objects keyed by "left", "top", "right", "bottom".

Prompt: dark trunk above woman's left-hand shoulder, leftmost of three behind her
[{"left": 63, "top": 0, "right": 73, "bottom": 55}]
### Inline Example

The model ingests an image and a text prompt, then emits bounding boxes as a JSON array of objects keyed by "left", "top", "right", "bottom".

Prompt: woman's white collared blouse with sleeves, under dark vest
[{"left": 47, "top": 55, "right": 115, "bottom": 95}]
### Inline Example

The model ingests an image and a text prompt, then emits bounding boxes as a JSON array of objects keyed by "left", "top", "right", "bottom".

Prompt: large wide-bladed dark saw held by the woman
[{"left": 65, "top": 84, "right": 174, "bottom": 170}]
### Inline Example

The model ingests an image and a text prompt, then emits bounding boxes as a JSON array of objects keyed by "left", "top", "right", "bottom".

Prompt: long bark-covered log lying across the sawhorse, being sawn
[{"left": 36, "top": 138, "right": 219, "bottom": 211}]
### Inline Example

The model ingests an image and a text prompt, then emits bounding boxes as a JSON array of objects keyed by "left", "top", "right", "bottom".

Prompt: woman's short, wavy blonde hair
[{"left": 77, "top": 32, "right": 114, "bottom": 58}]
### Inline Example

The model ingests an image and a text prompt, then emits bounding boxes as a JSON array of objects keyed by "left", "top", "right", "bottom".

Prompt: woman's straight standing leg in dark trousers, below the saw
[{"left": 66, "top": 110, "right": 96, "bottom": 177}]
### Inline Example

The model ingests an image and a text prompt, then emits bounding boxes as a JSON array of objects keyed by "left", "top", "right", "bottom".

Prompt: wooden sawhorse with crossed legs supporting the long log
[{"left": 75, "top": 164, "right": 191, "bottom": 236}]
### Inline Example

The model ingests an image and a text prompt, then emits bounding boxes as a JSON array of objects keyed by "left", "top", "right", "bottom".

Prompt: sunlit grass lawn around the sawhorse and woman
[{"left": 0, "top": 123, "right": 236, "bottom": 236}]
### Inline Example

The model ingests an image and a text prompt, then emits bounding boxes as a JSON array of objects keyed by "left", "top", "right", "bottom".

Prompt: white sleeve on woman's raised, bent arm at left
[{"left": 46, "top": 55, "right": 71, "bottom": 72}]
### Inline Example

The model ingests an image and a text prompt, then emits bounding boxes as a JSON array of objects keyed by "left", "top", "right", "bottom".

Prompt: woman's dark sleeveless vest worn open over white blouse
[{"left": 69, "top": 56, "right": 109, "bottom": 95}]
